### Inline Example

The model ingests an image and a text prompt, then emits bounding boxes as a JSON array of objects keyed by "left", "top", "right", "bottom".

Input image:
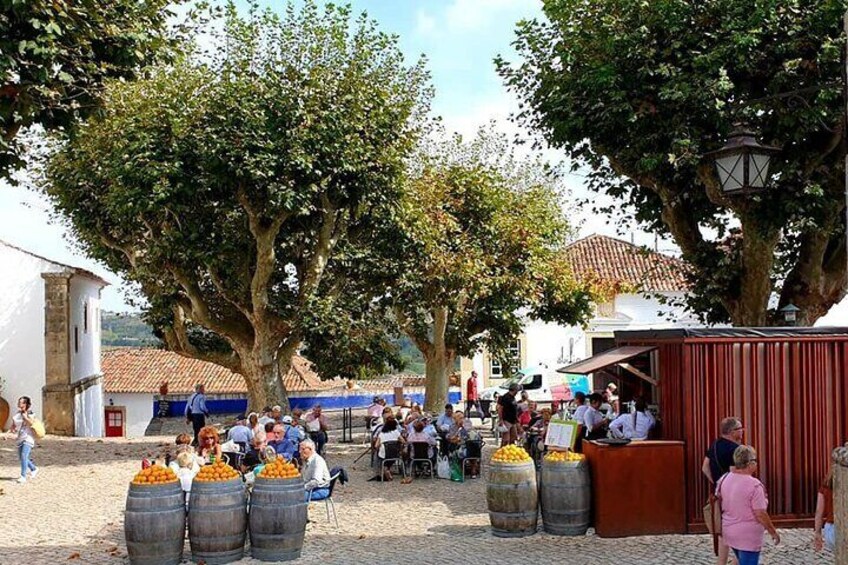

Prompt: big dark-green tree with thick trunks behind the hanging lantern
[{"left": 497, "top": 0, "right": 846, "bottom": 322}]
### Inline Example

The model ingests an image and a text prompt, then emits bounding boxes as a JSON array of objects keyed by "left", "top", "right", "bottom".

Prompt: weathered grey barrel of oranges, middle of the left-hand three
[{"left": 188, "top": 477, "right": 247, "bottom": 565}]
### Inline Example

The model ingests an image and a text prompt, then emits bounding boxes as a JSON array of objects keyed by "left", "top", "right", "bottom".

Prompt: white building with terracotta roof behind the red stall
[{"left": 461, "top": 235, "right": 700, "bottom": 391}]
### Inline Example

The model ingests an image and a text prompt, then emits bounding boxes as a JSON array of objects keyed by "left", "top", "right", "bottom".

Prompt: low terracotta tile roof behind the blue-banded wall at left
[{"left": 101, "top": 347, "right": 334, "bottom": 394}]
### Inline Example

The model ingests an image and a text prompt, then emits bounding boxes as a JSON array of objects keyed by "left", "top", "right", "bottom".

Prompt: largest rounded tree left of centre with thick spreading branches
[{"left": 45, "top": 2, "right": 430, "bottom": 404}]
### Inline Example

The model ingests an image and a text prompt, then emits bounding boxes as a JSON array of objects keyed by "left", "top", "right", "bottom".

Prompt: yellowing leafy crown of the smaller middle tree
[{"left": 391, "top": 126, "right": 591, "bottom": 366}]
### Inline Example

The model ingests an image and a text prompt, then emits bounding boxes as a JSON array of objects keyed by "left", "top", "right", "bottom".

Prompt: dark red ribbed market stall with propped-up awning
[{"left": 560, "top": 328, "right": 848, "bottom": 533}]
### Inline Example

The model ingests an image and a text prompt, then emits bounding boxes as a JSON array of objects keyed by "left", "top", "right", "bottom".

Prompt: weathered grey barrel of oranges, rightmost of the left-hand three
[{"left": 249, "top": 477, "right": 307, "bottom": 561}]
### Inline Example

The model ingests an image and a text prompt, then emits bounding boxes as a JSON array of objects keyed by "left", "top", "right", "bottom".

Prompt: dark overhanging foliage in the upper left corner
[{"left": 0, "top": 0, "right": 179, "bottom": 179}]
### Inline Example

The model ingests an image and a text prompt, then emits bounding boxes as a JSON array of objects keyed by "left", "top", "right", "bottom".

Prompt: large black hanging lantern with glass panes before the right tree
[{"left": 706, "top": 126, "right": 780, "bottom": 195}]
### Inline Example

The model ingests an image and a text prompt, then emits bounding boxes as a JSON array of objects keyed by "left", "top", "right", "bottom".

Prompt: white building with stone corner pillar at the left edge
[{"left": 0, "top": 241, "right": 109, "bottom": 436}]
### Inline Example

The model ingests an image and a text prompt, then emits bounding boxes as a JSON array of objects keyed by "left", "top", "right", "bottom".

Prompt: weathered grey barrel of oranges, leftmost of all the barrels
[{"left": 124, "top": 481, "right": 185, "bottom": 565}]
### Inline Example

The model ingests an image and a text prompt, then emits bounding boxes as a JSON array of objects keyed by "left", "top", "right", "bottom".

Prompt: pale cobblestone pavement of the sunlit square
[{"left": 0, "top": 428, "right": 833, "bottom": 565}]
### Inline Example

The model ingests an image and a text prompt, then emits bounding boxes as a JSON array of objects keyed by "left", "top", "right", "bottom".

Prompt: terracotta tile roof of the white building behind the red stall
[{"left": 565, "top": 235, "right": 689, "bottom": 292}]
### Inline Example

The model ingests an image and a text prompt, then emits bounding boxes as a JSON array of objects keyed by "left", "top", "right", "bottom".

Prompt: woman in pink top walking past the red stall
[{"left": 716, "top": 445, "right": 780, "bottom": 565}]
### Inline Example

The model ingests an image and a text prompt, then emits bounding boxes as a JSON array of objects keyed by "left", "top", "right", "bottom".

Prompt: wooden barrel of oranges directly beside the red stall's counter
[{"left": 539, "top": 459, "right": 592, "bottom": 536}]
